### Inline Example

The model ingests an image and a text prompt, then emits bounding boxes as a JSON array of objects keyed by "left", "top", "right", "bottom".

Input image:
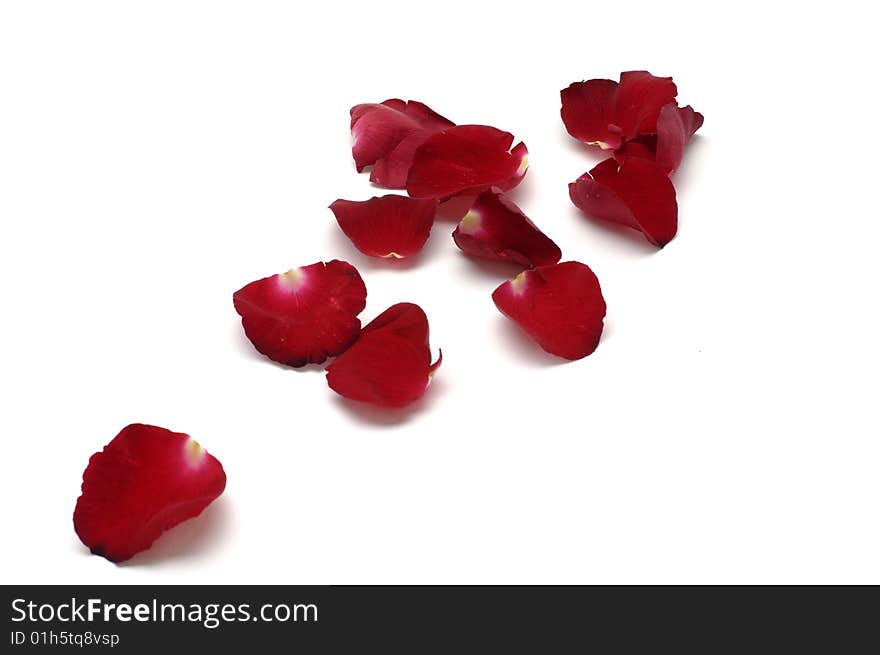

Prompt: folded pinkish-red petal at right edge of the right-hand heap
[{"left": 614, "top": 102, "right": 703, "bottom": 174}]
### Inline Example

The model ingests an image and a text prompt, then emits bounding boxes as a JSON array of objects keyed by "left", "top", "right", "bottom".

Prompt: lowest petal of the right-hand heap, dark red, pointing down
[{"left": 568, "top": 157, "right": 678, "bottom": 248}]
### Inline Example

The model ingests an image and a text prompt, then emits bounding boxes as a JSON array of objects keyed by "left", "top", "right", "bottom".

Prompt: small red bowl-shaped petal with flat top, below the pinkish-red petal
[{"left": 330, "top": 195, "right": 438, "bottom": 259}]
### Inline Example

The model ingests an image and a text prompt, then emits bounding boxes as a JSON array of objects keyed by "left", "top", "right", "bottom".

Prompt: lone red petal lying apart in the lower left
[{"left": 73, "top": 424, "right": 226, "bottom": 562}]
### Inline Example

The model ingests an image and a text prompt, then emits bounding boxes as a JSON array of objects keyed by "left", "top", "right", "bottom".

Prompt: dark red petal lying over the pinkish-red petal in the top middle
[{"left": 406, "top": 125, "right": 529, "bottom": 198}]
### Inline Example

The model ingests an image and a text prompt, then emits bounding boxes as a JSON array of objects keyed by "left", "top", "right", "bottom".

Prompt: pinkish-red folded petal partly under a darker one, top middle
[{"left": 351, "top": 98, "right": 454, "bottom": 178}]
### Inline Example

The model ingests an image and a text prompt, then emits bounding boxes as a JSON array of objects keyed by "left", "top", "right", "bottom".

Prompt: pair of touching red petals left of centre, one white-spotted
[{"left": 233, "top": 262, "right": 440, "bottom": 407}]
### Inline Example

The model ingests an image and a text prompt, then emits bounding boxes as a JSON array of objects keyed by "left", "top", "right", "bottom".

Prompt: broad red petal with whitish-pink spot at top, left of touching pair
[{"left": 232, "top": 259, "right": 367, "bottom": 366}]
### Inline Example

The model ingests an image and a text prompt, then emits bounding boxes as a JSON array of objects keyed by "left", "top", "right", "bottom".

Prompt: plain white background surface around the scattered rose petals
[{"left": 0, "top": 0, "right": 880, "bottom": 584}]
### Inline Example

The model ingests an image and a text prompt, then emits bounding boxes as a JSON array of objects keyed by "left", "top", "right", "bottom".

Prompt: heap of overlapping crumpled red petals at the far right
[{"left": 561, "top": 71, "right": 703, "bottom": 248}]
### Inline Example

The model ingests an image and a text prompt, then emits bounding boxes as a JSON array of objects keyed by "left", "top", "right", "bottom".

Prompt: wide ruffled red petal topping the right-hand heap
[{"left": 561, "top": 71, "right": 677, "bottom": 150}]
